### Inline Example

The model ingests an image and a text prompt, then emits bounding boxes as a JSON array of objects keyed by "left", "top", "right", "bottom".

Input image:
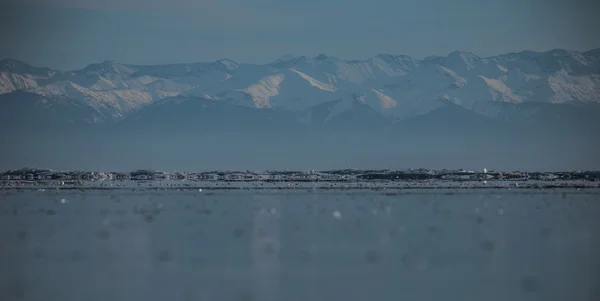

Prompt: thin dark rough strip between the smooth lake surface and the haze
[{"left": 0, "top": 169, "right": 600, "bottom": 190}]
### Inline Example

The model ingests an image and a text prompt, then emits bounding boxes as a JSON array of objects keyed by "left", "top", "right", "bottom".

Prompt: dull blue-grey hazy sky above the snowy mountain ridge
[{"left": 0, "top": 0, "right": 600, "bottom": 70}]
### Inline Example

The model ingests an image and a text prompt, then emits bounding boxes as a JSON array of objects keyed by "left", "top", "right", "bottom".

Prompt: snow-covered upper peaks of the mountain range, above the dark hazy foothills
[{"left": 0, "top": 49, "right": 600, "bottom": 129}]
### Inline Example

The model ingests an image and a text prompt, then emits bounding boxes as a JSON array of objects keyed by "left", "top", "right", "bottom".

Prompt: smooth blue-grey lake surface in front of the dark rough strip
[{"left": 0, "top": 189, "right": 600, "bottom": 301}]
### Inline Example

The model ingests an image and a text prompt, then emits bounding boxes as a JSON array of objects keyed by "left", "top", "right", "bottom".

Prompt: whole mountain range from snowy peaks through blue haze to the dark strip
[{"left": 0, "top": 49, "right": 600, "bottom": 169}]
